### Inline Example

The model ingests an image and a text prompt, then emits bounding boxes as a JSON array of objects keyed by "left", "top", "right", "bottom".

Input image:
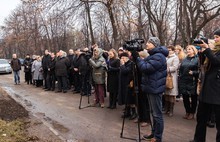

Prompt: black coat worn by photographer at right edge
[{"left": 199, "top": 49, "right": 220, "bottom": 105}]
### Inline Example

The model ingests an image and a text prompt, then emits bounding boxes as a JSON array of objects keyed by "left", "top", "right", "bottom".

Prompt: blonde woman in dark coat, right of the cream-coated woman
[{"left": 178, "top": 45, "right": 199, "bottom": 120}]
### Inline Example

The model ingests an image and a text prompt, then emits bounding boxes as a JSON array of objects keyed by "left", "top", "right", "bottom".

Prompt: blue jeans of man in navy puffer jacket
[{"left": 148, "top": 94, "right": 164, "bottom": 140}]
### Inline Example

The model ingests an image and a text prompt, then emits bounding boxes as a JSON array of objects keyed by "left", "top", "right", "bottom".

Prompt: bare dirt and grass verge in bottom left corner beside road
[{"left": 0, "top": 94, "right": 62, "bottom": 142}]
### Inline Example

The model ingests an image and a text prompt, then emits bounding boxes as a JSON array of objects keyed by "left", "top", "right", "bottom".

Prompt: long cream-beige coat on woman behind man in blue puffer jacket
[{"left": 165, "top": 53, "right": 179, "bottom": 96}]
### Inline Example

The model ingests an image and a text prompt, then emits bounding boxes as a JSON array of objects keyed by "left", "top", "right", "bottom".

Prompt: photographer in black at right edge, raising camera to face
[{"left": 190, "top": 29, "right": 220, "bottom": 142}]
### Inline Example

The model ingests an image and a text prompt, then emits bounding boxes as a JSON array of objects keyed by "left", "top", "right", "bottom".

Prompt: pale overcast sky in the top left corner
[{"left": 0, "top": 0, "right": 21, "bottom": 25}]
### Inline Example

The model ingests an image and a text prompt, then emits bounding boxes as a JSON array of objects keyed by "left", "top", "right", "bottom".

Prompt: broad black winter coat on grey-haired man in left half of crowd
[{"left": 55, "top": 57, "right": 70, "bottom": 76}]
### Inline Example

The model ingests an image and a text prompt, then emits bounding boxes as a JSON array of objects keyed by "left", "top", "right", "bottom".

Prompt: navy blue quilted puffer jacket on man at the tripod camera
[{"left": 137, "top": 46, "right": 169, "bottom": 94}]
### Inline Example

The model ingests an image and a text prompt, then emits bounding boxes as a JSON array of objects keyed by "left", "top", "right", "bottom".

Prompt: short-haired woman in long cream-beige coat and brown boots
[{"left": 165, "top": 46, "right": 179, "bottom": 117}]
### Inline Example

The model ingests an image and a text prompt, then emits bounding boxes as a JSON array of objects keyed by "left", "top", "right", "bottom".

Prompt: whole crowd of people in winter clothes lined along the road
[{"left": 11, "top": 30, "right": 220, "bottom": 142}]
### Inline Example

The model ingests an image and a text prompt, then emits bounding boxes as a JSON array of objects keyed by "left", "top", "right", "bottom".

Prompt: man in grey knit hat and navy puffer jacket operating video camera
[{"left": 132, "top": 37, "right": 169, "bottom": 142}]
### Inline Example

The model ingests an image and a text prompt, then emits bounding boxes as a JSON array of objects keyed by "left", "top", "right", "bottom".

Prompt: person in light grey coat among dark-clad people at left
[{"left": 31, "top": 56, "right": 43, "bottom": 87}]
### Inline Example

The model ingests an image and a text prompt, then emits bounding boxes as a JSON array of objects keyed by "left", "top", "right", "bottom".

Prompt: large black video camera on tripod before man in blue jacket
[{"left": 123, "top": 39, "right": 144, "bottom": 51}]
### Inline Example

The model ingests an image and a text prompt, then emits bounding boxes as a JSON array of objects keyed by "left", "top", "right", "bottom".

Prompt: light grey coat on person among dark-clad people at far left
[{"left": 31, "top": 60, "right": 43, "bottom": 80}]
